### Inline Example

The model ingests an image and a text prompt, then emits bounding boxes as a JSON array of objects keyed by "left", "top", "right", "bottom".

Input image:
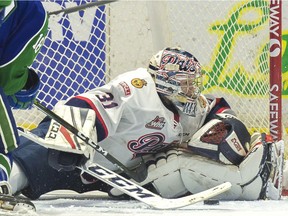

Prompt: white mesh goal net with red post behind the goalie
[{"left": 14, "top": 0, "right": 287, "bottom": 144}]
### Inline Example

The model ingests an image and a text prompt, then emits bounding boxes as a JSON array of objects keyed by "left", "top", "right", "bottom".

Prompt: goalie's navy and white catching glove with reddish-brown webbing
[{"left": 188, "top": 114, "right": 250, "bottom": 165}]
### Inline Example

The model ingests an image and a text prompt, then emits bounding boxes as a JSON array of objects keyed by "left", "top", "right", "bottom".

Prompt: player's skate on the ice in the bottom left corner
[{"left": 0, "top": 194, "right": 36, "bottom": 213}]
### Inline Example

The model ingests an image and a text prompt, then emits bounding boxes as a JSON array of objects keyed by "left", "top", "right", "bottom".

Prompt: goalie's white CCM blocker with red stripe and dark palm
[{"left": 45, "top": 103, "right": 97, "bottom": 170}]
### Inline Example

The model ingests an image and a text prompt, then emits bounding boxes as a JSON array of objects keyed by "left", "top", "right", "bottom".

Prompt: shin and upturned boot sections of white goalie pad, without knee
[{"left": 179, "top": 144, "right": 267, "bottom": 200}]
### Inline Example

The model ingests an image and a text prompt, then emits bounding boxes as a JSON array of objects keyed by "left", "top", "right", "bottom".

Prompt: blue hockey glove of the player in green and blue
[{"left": 7, "top": 69, "right": 40, "bottom": 109}]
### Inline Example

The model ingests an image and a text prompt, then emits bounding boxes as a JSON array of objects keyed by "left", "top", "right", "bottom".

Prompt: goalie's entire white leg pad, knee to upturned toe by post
[{"left": 147, "top": 133, "right": 281, "bottom": 200}]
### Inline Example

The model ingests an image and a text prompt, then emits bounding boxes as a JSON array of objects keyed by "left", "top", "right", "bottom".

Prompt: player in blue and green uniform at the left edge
[{"left": 0, "top": 0, "right": 48, "bottom": 209}]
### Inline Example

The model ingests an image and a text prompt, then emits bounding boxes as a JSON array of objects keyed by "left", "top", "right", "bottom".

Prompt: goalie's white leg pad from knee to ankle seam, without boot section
[{"left": 141, "top": 150, "right": 244, "bottom": 200}]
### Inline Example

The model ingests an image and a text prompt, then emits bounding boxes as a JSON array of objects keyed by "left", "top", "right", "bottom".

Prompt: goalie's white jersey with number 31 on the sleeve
[{"left": 66, "top": 68, "right": 215, "bottom": 170}]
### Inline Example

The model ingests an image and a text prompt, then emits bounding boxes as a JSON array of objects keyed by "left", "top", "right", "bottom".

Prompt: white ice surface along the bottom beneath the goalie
[{"left": 0, "top": 192, "right": 288, "bottom": 216}]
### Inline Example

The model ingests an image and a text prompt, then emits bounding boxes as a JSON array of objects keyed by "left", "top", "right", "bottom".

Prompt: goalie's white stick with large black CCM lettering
[{"left": 19, "top": 130, "right": 232, "bottom": 209}]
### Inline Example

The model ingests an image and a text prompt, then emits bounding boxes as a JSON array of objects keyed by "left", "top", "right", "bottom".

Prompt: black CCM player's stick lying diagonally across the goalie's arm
[{"left": 34, "top": 100, "right": 147, "bottom": 182}]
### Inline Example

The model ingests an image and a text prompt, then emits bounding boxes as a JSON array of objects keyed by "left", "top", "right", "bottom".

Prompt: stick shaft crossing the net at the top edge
[{"left": 48, "top": 0, "right": 117, "bottom": 16}]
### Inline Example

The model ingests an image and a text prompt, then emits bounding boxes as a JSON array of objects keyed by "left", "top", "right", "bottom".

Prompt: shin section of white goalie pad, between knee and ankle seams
[{"left": 179, "top": 154, "right": 242, "bottom": 200}]
